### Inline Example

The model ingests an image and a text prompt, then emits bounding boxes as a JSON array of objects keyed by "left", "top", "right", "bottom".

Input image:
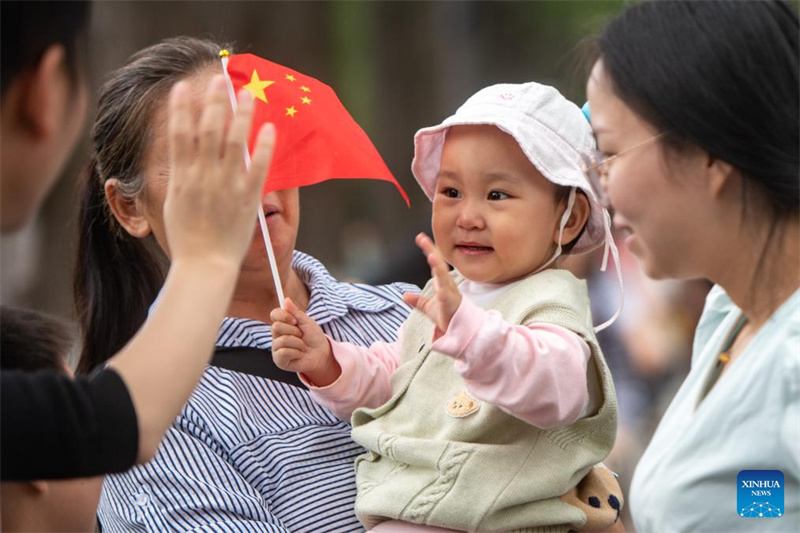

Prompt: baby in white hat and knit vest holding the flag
[{"left": 272, "top": 83, "right": 618, "bottom": 533}]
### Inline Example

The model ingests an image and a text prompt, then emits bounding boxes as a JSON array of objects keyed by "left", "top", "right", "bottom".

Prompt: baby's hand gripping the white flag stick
[{"left": 269, "top": 298, "right": 342, "bottom": 387}]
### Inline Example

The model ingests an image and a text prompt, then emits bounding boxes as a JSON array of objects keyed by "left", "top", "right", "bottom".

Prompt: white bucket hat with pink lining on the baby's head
[{"left": 411, "top": 82, "right": 606, "bottom": 253}]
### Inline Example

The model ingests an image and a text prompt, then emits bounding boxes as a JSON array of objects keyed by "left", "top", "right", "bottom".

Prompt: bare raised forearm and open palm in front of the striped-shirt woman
[{"left": 109, "top": 76, "right": 275, "bottom": 461}]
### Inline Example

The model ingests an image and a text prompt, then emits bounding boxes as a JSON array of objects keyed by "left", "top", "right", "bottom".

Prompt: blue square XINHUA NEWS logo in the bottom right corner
[{"left": 736, "top": 470, "right": 784, "bottom": 518}]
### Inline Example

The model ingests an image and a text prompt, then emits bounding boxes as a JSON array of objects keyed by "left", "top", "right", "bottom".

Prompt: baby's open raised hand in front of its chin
[{"left": 403, "top": 233, "right": 461, "bottom": 333}]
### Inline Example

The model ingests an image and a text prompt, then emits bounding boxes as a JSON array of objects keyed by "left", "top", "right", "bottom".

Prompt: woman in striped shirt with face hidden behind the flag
[{"left": 75, "top": 37, "right": 412, "bottom": 533}]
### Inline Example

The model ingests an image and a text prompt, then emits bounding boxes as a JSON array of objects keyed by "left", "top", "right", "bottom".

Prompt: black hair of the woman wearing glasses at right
[{"left": 596, "top": 0, "right": 800, "bottom": 298}]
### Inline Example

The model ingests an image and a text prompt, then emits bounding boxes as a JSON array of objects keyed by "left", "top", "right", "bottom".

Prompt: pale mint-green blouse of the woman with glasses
[{"left": 629, "top": 286, "right": 800, "bottom": 533}]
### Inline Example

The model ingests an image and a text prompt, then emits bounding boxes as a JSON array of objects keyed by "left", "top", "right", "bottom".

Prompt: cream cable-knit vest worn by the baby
[{"left": 353, "top": 270, "right": 617, "bottom": 533}]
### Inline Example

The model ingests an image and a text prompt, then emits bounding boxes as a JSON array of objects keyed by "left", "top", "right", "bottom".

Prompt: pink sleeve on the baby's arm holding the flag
[{"left": 299, "top": 328, "right": 403, "bottom": 422}]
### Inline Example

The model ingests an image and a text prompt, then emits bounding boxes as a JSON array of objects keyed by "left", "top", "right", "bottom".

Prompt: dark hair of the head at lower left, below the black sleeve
[{"left": 0, "top": 305, "right": 75, "bottom": 374}]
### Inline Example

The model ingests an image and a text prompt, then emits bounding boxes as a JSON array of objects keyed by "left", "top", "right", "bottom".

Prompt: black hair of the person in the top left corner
[{"left": 0, "top": 0, "right": 91, "bottom": 96}]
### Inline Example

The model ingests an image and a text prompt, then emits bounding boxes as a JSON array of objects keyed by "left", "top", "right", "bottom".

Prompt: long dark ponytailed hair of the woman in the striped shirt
[{"left": 73, "top": 37, "right": 221, "bottom": 373}]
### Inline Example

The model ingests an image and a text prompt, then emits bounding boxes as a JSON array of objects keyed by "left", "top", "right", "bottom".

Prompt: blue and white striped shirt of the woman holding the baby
[{"left": 98, "top": 252, "right": 417, "bottom": 533}]
